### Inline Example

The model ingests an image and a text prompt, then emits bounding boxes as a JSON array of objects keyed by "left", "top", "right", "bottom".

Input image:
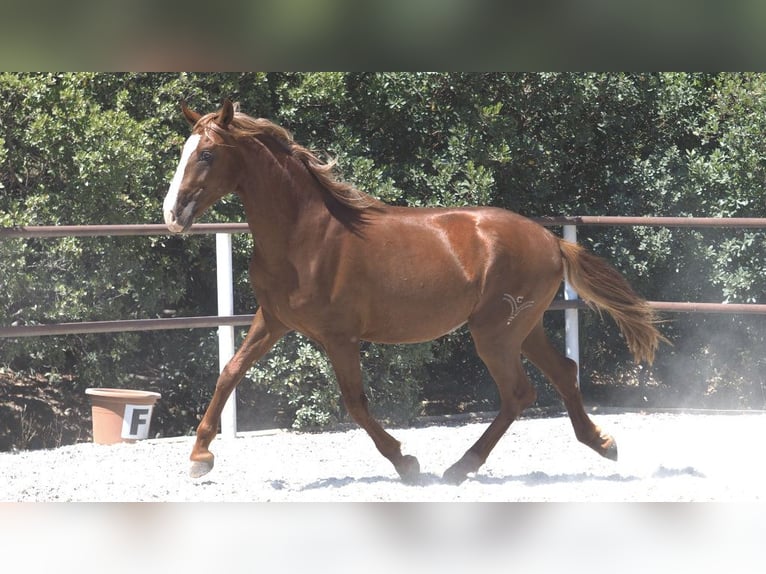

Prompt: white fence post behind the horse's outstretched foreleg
[{"left": 215, "top": 233, "right": 237, "bottom": 438}]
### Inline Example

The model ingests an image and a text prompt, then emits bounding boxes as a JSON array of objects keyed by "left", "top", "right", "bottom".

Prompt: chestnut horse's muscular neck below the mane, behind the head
[{"left": 238, "top": 140, "right": 331, "bottom": 257}]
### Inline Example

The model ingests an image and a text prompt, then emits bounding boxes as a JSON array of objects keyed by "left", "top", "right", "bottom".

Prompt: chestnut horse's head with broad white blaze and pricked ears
[{"left": 163, "top": 99, "right": 239, "bottom": 233}]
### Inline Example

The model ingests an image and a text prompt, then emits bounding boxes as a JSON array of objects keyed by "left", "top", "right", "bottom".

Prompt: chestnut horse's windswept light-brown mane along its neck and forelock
[{"left": 197, "top": 112, "right": 382, "bottom": 212}]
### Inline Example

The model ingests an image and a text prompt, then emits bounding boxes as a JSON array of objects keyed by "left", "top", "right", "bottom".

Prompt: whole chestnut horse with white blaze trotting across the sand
[{"left": 163, "top": 100, "right": 662, "bottom": 484}]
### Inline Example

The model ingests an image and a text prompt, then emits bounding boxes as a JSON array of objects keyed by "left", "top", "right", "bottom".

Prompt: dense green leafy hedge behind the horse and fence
[{"left": 0, "top": 73, "right": 766, "bottom": 440}]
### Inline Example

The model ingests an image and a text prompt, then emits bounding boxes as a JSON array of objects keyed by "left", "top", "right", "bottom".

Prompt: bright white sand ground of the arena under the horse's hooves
[{"left": 0, "top": 413, "right": 766, "bottom": 502}]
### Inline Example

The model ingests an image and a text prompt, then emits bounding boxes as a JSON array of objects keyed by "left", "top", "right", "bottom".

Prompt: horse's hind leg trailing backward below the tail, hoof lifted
[{"left": 521, "top": 322, "right": 617, "bottom": 460}]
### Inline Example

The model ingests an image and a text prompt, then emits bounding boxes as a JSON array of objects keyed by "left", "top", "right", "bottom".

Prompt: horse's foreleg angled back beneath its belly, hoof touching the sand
[{"left": 323, "top": 342, "right": 420, "bottom": 483}]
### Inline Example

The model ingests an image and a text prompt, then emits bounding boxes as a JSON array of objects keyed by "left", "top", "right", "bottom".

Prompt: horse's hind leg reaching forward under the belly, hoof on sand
[{"left": 443, "top": 326, "right": 537, "bottom": 484}]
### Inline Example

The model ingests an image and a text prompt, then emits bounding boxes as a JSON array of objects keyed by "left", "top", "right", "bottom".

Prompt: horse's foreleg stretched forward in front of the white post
[{"left": 189, "top": 309, "right": 288, "bottom": 478}]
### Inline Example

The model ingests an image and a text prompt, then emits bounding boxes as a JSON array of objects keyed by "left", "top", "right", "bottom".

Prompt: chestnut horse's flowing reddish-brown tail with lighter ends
[{"left": 559, "top": 240, "right": 667, "bottom": 364}]
